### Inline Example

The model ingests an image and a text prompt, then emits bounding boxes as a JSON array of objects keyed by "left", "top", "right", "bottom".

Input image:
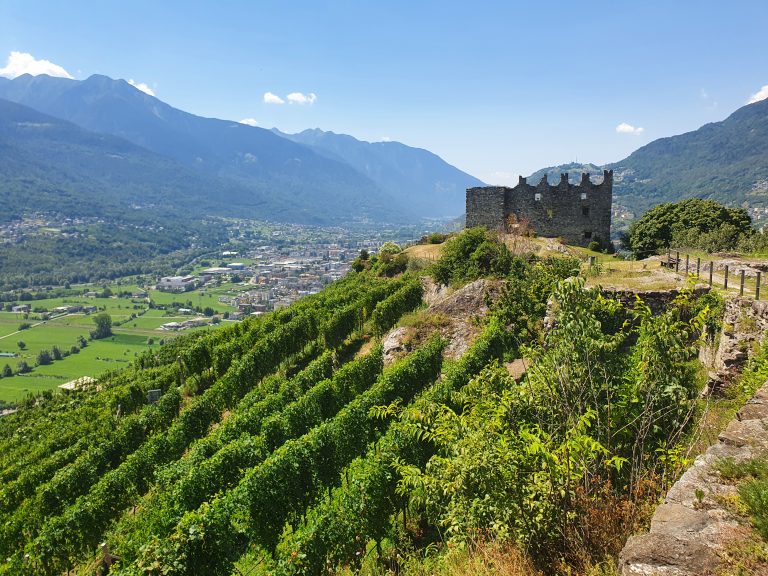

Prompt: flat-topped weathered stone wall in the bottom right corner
[{"left": 619, "top": 383, "right": 768, "bottom": 576}]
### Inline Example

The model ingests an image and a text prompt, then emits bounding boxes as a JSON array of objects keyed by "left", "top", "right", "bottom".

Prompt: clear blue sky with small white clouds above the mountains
[{"left": 0, "top": 0, "right": 768, "bottom": 184}]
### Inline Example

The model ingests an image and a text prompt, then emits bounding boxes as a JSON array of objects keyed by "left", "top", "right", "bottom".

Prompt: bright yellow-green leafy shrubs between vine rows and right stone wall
[{"left": 378, "top": 280, "right": 702, "bottom": 558}]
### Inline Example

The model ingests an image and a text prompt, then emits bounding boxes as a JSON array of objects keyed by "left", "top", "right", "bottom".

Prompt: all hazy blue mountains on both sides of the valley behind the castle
[{"left": 0, "top": 75, "right": 768, "bottom": 232}]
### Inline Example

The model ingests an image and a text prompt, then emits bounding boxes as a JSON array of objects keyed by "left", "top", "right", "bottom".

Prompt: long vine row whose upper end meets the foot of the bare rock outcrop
[{"left": 138, "top": 340, "right": 442, "bottom": 575}]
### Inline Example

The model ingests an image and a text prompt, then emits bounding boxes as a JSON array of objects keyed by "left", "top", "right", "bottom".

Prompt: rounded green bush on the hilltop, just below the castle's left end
[{"left": 432, "top": 227, "right": 513, "bottom": 284}]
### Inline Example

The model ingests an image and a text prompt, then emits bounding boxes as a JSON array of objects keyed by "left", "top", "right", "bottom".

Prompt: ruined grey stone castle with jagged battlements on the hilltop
[{"left": 467, "top": 170, "right": 613, "bottom": 246}]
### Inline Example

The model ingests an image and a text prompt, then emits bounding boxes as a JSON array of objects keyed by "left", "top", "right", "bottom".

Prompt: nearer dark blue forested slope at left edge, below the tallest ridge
[{"left": 0, "top": 99, "right": 266, "bottom": 220}]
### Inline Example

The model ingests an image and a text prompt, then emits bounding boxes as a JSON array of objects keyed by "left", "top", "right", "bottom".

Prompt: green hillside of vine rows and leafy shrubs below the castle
[{"left": 0, "top": 232, "right": 720, "bottom": 575}]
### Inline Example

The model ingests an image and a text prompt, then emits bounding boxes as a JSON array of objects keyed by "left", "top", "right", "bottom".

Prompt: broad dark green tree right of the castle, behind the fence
[{"left": 629, "top": 198, "right": 754, "bottom": 258}]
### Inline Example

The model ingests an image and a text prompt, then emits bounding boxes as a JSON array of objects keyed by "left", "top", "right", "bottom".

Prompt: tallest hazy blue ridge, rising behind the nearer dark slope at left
[{"left": 0, "top": 75, "right": 403, "bottom": 223}]
